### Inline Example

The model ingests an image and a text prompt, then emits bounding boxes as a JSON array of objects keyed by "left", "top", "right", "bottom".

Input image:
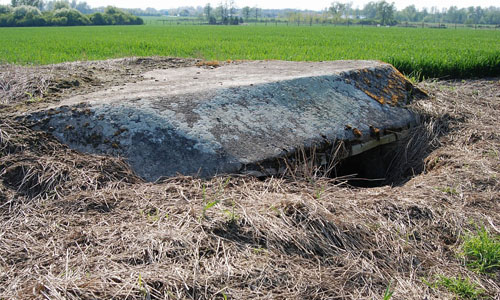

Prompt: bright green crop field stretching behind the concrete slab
[{"left": 0, "top": 25, "right": 500, "bottom": 78}]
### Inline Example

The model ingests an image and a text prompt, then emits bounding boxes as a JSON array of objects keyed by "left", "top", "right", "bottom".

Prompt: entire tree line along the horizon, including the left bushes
[{"left": 0, "top": 0, "right": 500, "bottom": 26}]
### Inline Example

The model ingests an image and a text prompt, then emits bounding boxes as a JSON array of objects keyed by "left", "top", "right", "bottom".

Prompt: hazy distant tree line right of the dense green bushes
[{"left": 157, "top": 0, "right": 500, "bottom": 25}]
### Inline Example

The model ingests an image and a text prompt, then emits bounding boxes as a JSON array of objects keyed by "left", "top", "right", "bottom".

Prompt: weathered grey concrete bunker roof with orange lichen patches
[{"left": 22, "top": 61, "right": 417, "bottom": 180}]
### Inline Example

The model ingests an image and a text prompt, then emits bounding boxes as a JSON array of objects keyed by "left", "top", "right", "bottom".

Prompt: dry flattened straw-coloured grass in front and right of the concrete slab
[{"left": 0, "top": 74, "right": 500, "bottom": 299}]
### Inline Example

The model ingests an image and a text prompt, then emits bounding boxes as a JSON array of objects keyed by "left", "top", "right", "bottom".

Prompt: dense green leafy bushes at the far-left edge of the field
[{"left": 0, "top": 0, "right": 144, "bottom": 27}]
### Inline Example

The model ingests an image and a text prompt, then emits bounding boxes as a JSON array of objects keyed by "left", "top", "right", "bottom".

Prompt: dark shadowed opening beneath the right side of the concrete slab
[{"left": 246, "top": 122, "right": 445, "bottom": 187}]
